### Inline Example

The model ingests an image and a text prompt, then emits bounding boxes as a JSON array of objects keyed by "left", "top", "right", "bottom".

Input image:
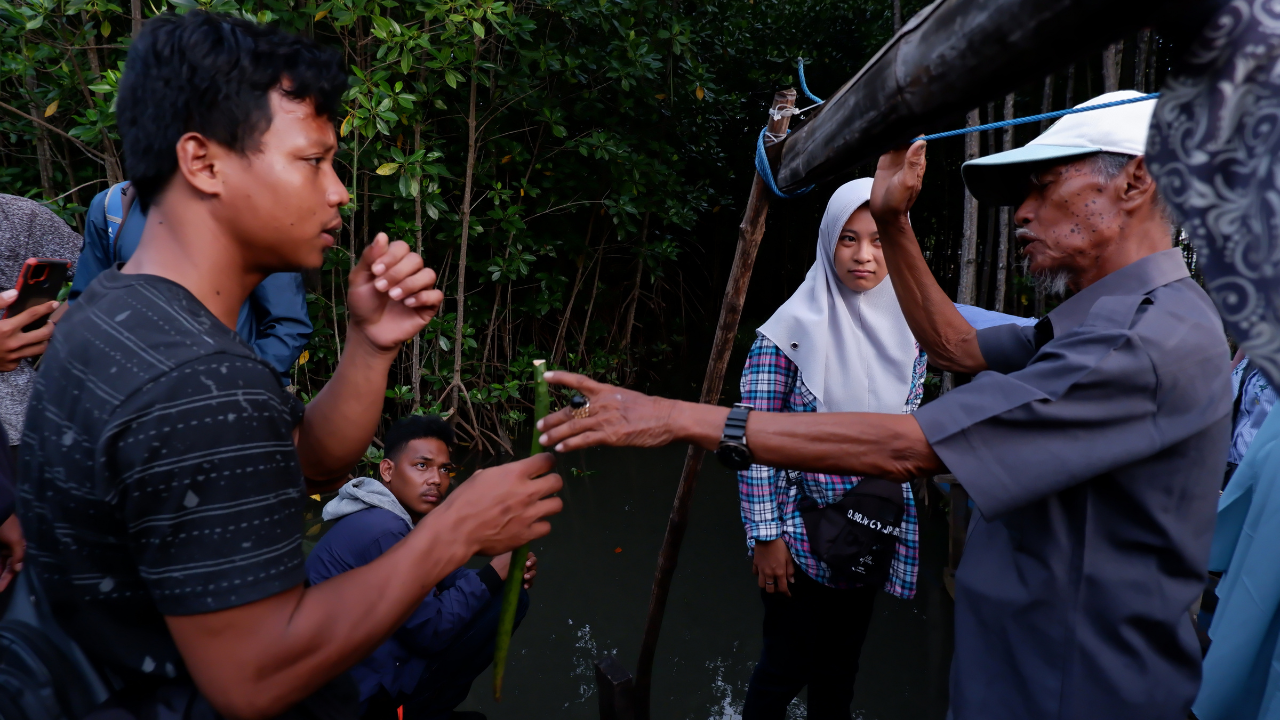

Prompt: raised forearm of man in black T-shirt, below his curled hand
[{"left": 297, "top": 332, "right": 397, "bottom": 486}]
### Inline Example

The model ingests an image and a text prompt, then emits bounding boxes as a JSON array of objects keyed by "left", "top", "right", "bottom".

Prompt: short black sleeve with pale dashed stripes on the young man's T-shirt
[{"left": 105, "top": 355, "right": 305, "bottom": 615}]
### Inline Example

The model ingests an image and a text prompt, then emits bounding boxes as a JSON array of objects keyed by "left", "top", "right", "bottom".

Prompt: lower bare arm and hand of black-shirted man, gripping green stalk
[{"left": 165, "top": 454, "right": 563, "bottom": 720}]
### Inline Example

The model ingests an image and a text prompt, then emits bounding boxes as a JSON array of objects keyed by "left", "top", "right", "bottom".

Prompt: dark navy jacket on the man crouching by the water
[{"left": 307, "top": 507, "right": 503, "bottom": 702}]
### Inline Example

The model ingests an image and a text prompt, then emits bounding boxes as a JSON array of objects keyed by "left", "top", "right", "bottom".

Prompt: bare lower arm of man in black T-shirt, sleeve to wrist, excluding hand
[{"left": 166, "top": 504, "right": 474, "bottom": 720}]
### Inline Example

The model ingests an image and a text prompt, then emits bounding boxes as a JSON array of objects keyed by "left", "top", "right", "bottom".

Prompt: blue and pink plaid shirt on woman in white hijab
[{"left": 737, "top": 336, "right": 927, "bottom": 598}]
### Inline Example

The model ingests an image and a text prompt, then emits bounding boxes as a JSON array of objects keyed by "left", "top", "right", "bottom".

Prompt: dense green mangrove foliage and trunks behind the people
[{"left": 0, "top": 0, "right": 1177, "bottom": 450}]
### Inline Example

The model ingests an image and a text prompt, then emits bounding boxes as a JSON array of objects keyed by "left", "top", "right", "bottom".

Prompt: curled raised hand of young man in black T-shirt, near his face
[{"left": 347, "top": 233, "right": 444, "bottom": 351}]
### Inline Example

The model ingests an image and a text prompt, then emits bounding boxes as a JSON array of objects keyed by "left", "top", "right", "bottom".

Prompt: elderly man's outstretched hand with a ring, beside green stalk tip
[{"left": 538, "top": 370, "right": 677, "bottom": 452}]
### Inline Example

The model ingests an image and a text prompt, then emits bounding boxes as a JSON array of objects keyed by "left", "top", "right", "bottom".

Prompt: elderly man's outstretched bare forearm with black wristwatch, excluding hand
[{"left": 672, "top": 402, "right": 945, "bottom": 482}]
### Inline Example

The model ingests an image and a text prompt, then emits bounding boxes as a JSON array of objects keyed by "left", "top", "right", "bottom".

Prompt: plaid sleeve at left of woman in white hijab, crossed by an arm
[{"left": 737, "top": 336, "right": 797, "bottom": 546}]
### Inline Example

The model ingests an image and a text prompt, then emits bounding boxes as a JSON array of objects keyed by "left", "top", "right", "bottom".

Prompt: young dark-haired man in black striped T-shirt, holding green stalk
[{"left": 19, "top": 12, "right": 561, "bottom": 719}]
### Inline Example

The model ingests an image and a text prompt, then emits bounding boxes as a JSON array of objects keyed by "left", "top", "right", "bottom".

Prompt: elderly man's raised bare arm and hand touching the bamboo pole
[{"left": 870, "top": 141, "right": 987, "bottom": 373}]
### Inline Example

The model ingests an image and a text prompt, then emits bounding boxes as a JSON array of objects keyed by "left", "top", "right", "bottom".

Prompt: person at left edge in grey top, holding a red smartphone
[{"left": 0, "top": 193, "right": 81, "bottom": 592}]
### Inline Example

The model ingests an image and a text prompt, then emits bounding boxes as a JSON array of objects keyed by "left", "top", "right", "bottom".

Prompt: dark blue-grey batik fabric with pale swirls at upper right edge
[{"left": 1147, "top": 0, "right": 1280, "bottom": 383}]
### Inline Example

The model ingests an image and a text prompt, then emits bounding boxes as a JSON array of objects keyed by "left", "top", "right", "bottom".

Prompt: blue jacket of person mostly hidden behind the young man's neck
[{"left": 69, "top": 190, "right": 311, "bottom": 384}]
